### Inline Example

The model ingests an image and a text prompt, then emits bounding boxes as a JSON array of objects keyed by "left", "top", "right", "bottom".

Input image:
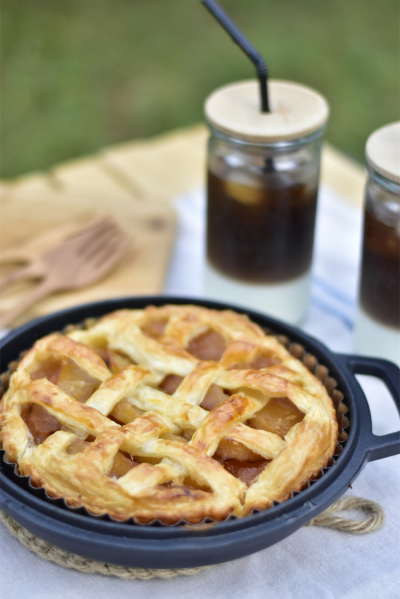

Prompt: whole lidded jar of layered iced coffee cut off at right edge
[{"left": 355, "top": 123, "right": 400, "bottom": 366}]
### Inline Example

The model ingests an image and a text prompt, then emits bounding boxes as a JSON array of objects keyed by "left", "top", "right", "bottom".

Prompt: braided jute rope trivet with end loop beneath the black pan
[{"left": 0, "top": 497, "right": 385, "bottom": 580}]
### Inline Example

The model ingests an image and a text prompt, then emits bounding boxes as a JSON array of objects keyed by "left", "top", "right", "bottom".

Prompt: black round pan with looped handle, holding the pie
[{"left": 0, "top": 296, "right": 400, "bottom": 569}]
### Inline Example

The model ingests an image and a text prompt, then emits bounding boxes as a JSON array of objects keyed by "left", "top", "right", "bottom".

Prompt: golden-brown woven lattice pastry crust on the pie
[{"left": 0, "top": 306, "right": 338, "bottom": 523}]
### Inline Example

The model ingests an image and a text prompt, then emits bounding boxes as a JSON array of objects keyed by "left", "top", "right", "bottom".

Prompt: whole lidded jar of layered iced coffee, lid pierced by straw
[{"left": 204, "top": 81, "right": 329, "bottom": 323}]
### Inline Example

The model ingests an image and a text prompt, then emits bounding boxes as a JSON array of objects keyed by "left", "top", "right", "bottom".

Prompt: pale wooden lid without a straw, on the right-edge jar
[{"left": 365, "top": 122, "right": 400, "bottom": 183}]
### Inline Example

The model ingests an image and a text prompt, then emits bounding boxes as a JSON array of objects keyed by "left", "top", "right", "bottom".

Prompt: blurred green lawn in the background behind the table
[{"left": 1, "top": 0, "right": 399, "bottom": 177}]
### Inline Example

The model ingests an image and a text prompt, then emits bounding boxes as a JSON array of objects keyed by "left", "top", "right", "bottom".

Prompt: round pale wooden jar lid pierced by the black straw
[{"left": 205, "top": 80, "right": 329, "bottom": 144}]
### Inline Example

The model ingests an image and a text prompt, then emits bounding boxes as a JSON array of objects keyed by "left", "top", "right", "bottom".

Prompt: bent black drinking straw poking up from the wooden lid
[{"left": 201, "top": 0, "right": 270, "bottom": 112}]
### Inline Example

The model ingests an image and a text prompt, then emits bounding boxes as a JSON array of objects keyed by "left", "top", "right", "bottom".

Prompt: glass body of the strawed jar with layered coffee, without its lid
[{"left": 204, "top": 81, "right": 325, "bottom": 323}]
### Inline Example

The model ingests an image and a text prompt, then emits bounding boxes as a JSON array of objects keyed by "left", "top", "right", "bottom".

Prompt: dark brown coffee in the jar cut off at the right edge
[{"left": 360, "top": 204, "right": 400, "bottom": 328}]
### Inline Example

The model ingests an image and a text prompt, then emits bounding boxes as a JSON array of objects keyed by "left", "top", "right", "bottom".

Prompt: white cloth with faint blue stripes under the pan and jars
[{"left": 0, "top": 187, "right": 400, "bottom": 599}]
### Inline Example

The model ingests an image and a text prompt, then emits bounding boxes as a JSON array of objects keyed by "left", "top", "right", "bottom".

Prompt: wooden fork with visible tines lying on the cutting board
[{"left": 0, "top": 219, "right": 131, "bottom": 329}]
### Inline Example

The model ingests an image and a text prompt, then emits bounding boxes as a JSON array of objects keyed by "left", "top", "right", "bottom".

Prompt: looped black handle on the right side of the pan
[{"left": 340, "top": 354, "right": 400, "bottom": 462}]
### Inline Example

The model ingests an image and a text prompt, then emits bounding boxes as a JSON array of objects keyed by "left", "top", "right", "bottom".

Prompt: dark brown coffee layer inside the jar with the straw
[{"left": 207, "top": 172, "right": 317, "bottom": 283}]
